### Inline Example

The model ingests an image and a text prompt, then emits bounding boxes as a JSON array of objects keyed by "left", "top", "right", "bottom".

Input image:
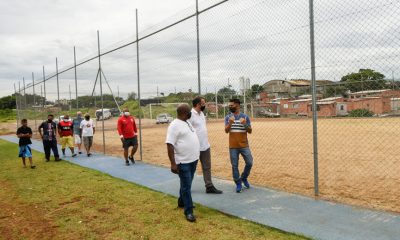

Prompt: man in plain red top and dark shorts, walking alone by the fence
[{"left": 118, "top": 108, "right": 138, "bottom": 166}]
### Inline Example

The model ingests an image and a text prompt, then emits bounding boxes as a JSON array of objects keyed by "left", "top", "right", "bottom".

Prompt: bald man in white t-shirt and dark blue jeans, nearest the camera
[{"left": 165, "top": 104, "right": 200, "bottom": 222}]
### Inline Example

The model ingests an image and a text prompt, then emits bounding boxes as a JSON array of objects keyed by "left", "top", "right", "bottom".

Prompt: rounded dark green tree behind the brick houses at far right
[{"left": 340, "top": 69, "right": 386, "bottom": 92}]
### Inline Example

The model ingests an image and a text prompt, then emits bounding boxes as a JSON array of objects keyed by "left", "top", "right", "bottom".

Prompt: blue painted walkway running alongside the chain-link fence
[{"left": 1, "top": 136, "right": 400, "bottom": 240}]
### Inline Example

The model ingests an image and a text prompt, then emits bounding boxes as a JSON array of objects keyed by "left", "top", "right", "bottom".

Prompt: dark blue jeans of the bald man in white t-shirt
[{"left": 178, "top": 160, "right": 198, "bottom": 215}]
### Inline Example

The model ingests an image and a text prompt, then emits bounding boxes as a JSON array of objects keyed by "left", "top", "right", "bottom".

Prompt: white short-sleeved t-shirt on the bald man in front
[{"left": 165, "top": 119, "right": 200, "bottom": 164}]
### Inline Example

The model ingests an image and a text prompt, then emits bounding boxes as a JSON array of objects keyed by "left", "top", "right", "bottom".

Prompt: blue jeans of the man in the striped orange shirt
[{"left": 229, "top": 147, "right": 253, "bottom": 183}]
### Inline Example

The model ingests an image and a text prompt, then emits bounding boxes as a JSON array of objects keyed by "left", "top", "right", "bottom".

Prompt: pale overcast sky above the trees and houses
[{"left": 0, "top": 0, "right": 400, "bottom": 99}]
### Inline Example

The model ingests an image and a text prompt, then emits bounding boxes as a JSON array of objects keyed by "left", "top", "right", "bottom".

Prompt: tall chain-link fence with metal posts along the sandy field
[{"left": 15, "top": 0, "right": 400, "bottom": 212}]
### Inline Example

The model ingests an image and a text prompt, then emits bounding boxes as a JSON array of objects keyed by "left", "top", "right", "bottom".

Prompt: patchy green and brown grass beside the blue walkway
[{"left": 0, "top": 140, "right": 305, "bottom": 239}]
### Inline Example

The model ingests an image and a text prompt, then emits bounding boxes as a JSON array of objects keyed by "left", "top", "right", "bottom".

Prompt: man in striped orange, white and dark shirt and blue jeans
[{"left": 225, "top": 99, "right": 253, "bottom": 193}]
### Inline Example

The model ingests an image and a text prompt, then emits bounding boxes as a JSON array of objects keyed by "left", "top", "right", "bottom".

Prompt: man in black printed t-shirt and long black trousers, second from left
[{"left": 38, "top": 114, "right": 60, "bottom": 162}]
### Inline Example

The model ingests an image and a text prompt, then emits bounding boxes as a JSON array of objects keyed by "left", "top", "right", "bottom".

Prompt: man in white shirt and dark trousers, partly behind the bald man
[{"left": 188, "top": 97, "right": 222, "bottom": 194}]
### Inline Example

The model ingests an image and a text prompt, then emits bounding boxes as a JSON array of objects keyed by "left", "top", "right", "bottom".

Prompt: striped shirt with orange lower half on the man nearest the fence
[{"left": 225, "top": 113, "right": 251, "bottom": 148}]
